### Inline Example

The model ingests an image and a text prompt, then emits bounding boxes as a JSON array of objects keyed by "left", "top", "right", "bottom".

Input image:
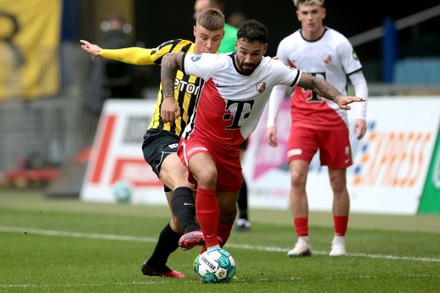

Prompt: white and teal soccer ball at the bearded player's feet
[{"left": 194, "top": 248, "right": 235, "bottom": 283}]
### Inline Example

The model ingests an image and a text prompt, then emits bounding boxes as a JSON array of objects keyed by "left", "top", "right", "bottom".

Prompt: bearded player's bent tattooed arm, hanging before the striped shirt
[{"left": 160, "top": 52, "right": 184, "bottom": 124}]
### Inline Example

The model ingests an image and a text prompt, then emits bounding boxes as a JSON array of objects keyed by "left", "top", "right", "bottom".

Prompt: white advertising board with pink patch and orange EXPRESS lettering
[{"left": 243, "top": 97, "right": 440, "bottom": 214}]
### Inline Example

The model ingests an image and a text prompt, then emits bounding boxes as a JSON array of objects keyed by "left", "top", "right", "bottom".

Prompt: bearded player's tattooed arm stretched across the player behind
[{"left": 298, "top": 72, "right": 366, "bottom": 110}]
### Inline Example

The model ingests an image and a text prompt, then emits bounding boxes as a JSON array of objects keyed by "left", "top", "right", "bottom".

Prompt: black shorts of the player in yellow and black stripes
[{"left": 142, "top": 130, "right": 179, "bottom": 192}]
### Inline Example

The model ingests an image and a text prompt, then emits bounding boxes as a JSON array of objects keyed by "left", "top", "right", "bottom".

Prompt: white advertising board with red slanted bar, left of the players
[{"left": 80, "top": 99, "right": 166, "bottom": 204}]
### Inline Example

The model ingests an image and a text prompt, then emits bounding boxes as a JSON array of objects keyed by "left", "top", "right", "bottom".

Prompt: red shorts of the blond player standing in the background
[{"left": 287, "top": 127, "right": 352, "bottom": 169}]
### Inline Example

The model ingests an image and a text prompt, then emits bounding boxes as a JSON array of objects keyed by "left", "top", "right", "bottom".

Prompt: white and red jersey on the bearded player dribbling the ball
[{"left": 183, "top": 53, "right": 301, "bottom": 149}]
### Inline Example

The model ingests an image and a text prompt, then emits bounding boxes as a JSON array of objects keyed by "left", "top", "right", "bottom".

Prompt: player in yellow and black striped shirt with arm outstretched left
[{"left": 81, "top": 9, "right": 225, "bottom": 278}]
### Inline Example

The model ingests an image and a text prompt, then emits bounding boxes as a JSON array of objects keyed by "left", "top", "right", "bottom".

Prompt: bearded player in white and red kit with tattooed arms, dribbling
[{"left": 161, "top": 20, "right": 363, "bottom": 251}]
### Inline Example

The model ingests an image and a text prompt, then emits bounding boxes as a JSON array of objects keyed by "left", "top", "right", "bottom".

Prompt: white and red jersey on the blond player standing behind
[{"left": 277, "top": 27, "right": 362, "bottom": 130}]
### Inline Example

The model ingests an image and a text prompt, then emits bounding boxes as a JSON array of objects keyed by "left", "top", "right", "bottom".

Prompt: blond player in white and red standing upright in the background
[{"left": 267, "top": 0, "right": 368, "bottom": 257}]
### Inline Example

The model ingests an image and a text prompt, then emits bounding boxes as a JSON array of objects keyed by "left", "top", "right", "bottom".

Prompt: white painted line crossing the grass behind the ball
[{"left": 0, "top": 226, "right": 440, "bottom": 262}]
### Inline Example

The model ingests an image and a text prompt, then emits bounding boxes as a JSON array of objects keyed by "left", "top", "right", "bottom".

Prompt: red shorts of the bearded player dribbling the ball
[{"left": 177, "top": 137, "right": 242, "bottom": 192}]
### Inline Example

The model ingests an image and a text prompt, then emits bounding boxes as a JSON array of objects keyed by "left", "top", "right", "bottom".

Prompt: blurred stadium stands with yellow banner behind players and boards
[{"left": 0, "top": 0, "right": 440, "bottom": 212}]
